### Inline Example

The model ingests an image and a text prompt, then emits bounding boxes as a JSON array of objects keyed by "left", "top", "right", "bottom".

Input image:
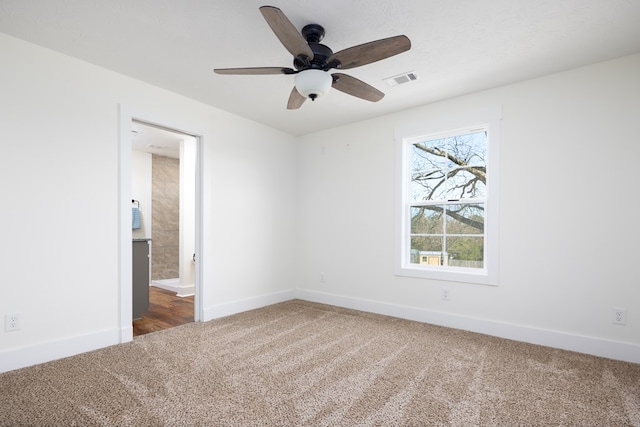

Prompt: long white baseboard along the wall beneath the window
[{"left": 296, "top": 289, "right": 640, "bottom": 363}]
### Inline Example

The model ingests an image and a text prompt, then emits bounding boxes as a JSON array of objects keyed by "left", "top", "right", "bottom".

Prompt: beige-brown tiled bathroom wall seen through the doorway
[{"left": 151, "top": 154, "right": 180, "bottom": 280}]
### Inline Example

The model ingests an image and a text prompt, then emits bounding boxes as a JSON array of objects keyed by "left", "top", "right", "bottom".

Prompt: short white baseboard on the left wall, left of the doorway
[{"left": 0, "top": 329, "right": 120, "bottom": 373}]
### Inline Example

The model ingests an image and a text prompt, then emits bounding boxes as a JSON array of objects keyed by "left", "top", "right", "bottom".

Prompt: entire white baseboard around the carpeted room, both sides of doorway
[{"left": 0, "top": 289, "right": 640, "bottom": 373}]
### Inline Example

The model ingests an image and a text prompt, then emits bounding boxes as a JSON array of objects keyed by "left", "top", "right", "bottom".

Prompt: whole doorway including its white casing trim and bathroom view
[{"left": 120, "top": 106, "right": 202, "bottom": 342}]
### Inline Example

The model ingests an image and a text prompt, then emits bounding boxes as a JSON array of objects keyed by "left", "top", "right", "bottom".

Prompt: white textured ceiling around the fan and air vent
[{"left": 0, "top": 0, "right": 640, "bottom": 135}]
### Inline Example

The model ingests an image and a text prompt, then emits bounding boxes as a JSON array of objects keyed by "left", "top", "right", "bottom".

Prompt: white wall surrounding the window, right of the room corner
[{"left": 297, "top": 51, "right": 640, "bottom": 362}]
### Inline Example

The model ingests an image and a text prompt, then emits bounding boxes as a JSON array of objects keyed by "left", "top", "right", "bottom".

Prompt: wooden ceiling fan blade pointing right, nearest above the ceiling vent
[{"left": 327, "top": 36, "right": 411, "bottom": 70}]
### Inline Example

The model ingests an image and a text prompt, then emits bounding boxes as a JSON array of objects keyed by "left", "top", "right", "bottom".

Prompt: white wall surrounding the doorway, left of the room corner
[{"left": 0, "top": 34, "right": 296, "bottom": 371}]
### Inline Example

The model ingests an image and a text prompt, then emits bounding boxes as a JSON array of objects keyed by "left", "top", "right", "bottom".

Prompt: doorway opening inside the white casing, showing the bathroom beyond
[{"left": 131, "top": 119, "right": 196, "bottom": 337}]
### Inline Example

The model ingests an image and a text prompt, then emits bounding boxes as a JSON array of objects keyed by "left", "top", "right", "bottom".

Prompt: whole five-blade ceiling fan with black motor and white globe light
[{"left": 213, "top": 6, "right": 411, "bottom": 110}]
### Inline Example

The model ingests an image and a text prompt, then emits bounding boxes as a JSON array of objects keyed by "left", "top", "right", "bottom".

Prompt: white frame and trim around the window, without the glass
[{"left": 395, "top": 106, "right": 502, "bottom": 285}]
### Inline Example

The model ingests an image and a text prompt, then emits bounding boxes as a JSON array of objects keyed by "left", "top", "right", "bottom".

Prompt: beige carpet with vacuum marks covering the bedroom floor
[{"left": 0, "top": 300, "right": 640, "bottom": 426}]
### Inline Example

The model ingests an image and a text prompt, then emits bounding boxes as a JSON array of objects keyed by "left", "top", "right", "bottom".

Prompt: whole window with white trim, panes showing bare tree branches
[{"left": 396, "top": 108, "right": 499, "bottom": 284}]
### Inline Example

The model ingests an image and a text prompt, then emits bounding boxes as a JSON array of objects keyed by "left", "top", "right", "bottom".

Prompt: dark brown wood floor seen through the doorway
[{"left": 133, "top": 286, "right": 193, "bottom": 337}]
